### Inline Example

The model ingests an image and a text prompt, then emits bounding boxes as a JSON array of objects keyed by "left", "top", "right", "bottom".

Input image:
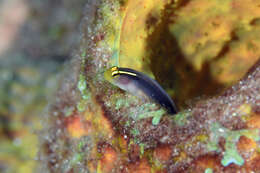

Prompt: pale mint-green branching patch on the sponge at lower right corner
[{"left": 208, "top": 123, "right": 260, "bottom": 166}]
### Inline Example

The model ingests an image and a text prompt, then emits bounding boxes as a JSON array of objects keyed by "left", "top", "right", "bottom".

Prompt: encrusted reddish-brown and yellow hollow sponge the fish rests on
[{"left": 39, "top": 0, "right": 260, "bottom": 172}]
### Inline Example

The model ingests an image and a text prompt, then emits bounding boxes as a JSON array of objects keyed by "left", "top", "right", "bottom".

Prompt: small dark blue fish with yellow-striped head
[{"left": 104, "top": 67, "right": 177, "bottom": 114}]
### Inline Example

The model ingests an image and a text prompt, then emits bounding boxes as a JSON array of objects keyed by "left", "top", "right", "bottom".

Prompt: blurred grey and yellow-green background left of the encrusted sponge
[{"left": 0, "top": 0, "right": 85, "bottom": 173}]
